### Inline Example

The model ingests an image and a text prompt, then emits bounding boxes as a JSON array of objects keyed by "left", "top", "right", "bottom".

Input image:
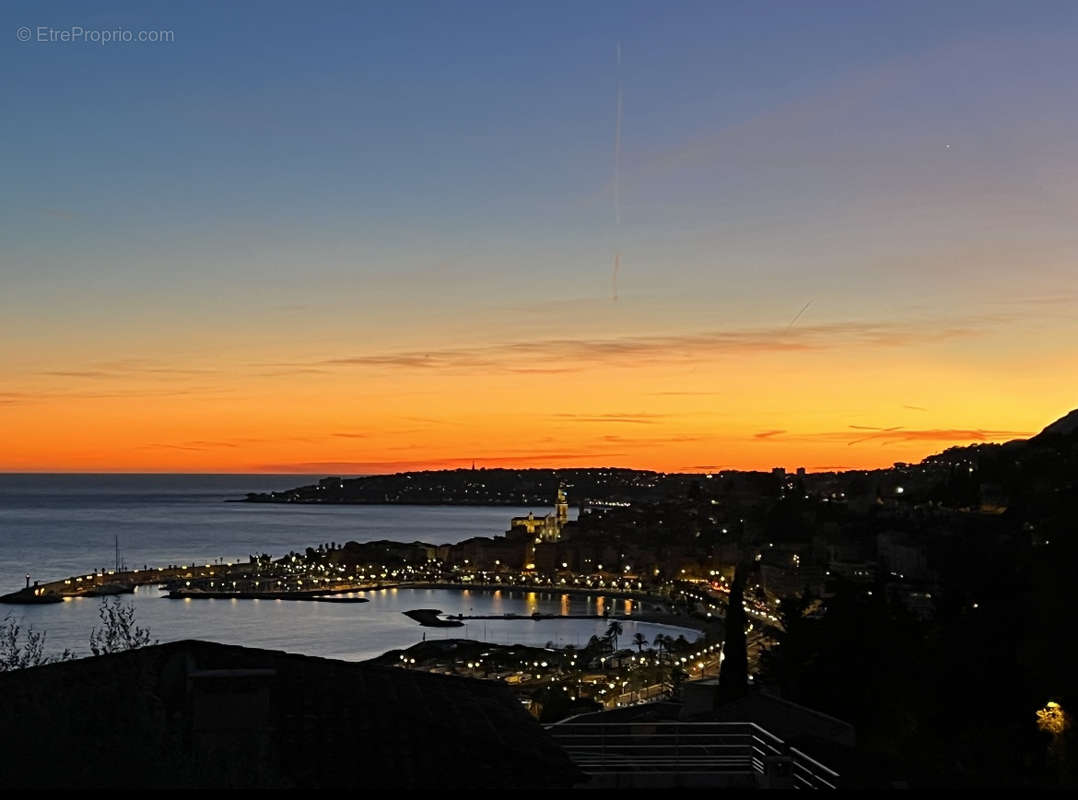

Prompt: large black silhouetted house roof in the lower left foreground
[{"left": 0, "top": 640, "right": 584, "bottom": 789}]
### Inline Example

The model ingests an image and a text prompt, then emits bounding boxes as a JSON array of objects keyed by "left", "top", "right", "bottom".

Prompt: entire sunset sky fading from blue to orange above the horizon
[{"left": 0, "top": 1, "right": 1078, "bottom": 474}]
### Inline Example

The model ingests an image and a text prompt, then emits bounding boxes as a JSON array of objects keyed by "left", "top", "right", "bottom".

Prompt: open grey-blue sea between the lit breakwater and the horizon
[{"left": 0, "top": 474, "right": 573, "bottom": 593}]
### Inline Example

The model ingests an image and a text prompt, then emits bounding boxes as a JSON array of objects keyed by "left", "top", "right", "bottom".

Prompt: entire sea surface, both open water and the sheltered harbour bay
[{"left": 0, "top": 473, "right": 699, "bottom": 661}]
